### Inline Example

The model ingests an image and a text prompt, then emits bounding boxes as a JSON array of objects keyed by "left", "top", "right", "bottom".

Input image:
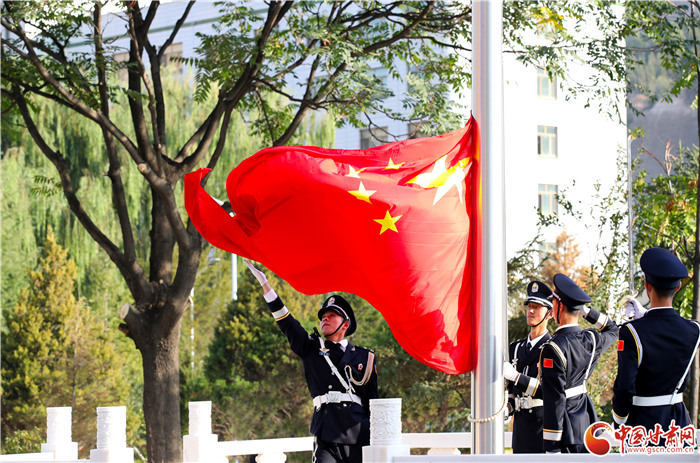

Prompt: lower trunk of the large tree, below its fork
[{"left": 140, "top": 316, "right": 182, "bottom": 463}]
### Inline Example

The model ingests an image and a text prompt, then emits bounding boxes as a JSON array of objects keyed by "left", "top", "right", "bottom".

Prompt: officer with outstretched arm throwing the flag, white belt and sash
[{"left": 246, "top": 261, "right": 379, "bottom": 463}]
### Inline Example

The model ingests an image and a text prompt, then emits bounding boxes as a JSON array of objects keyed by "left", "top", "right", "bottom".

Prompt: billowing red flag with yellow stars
[{"left": 185, "top": 118, "right": 481, "bottom": 374}]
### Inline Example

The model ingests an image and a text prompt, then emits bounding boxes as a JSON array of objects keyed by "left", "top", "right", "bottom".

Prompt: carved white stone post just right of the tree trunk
[{"left": 182, "top": 402, "right": 228, "bottom": 463}]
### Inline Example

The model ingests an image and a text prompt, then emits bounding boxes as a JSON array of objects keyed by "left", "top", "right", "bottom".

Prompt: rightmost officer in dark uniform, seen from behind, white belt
[{"left": 613, "top": 248, "right": 700, "bottom": 431}]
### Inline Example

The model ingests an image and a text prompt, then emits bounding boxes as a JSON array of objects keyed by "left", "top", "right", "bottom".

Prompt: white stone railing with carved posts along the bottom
[{"left": 0, "top": 399, "right": 700, "bottom": 463}]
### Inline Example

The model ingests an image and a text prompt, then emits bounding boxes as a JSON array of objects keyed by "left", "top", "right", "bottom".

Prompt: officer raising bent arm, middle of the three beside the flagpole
[{"left": 539, "top": 273, "right": 619, "bottom": 453}]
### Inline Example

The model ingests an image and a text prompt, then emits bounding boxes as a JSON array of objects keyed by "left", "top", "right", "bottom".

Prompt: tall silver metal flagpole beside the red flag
[{"left": 472, "top": 0, "right": 506, "bottom": 454}]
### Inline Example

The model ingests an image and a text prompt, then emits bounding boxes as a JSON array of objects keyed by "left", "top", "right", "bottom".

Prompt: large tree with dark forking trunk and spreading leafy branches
[{"left": 2, "top": 1, "right": 640, "bottom": 462}]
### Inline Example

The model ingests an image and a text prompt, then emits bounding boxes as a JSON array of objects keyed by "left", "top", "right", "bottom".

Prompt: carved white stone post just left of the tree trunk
[{"left": 90, "top": 407, "right": 134, "bottom": 463}]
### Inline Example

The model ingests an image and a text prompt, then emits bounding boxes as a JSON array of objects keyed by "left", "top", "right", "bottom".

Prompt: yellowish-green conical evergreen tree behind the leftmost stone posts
[{"left": 2, "top": 229, "right": 139, "bottom": 457}]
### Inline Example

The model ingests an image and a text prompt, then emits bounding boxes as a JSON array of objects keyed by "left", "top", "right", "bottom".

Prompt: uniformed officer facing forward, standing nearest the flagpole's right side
[{"left": 503, "top": 281, "right": 552, "bottom": 453}]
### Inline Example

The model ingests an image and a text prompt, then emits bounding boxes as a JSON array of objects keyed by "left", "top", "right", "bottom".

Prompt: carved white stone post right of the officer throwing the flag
[{"left": 362, "top": 399, "right": 411, "bottom": 463}]
